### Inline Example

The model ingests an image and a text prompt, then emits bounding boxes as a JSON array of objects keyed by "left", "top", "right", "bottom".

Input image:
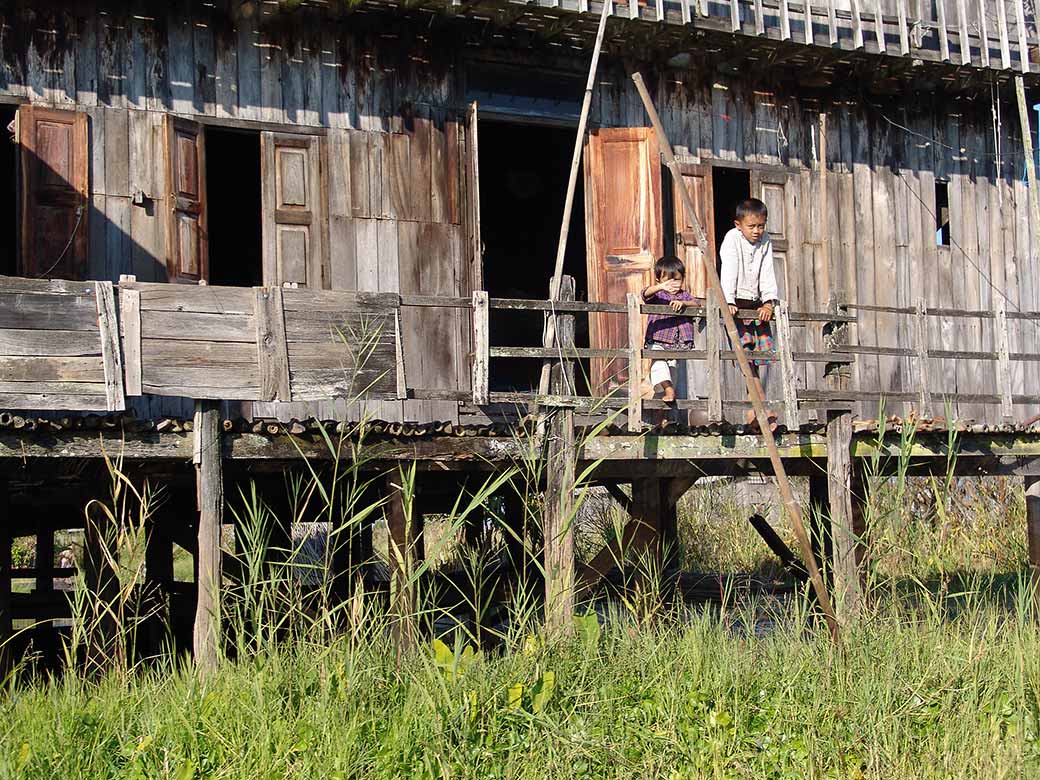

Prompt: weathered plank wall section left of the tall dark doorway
[{"left": 0, "top": 0, "right": 472, "bottom": 420}]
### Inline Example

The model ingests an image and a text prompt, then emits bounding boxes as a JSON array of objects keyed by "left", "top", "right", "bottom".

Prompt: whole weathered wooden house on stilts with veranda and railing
[{"left": 0, "top": 0, "right": 1040, "bottom": 673}]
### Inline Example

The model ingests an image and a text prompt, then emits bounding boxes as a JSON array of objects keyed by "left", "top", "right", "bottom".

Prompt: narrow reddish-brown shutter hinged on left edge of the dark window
[{"left": 164, "top": 114, "right": 209, "bottom": 283}]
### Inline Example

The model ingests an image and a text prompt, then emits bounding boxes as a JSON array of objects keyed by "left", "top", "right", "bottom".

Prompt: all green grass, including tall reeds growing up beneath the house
[{"left": 0, "top": 416, "right": 1040, "bottom": 780}]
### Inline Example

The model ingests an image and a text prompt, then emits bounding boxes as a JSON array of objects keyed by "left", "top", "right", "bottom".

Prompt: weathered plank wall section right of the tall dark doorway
[{"left": 596, "top": 64, "right": 1040, "bottom": 422}]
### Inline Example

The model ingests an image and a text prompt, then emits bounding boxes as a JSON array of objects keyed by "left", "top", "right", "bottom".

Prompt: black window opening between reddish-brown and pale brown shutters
[{"left": 206, "top": 127, "right": 263, "bottom": 287}]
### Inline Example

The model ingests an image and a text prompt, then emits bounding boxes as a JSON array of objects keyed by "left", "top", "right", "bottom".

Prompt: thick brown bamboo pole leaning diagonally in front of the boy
[{"left": 632, "top": 73, "right": 839, "bottom": 642}]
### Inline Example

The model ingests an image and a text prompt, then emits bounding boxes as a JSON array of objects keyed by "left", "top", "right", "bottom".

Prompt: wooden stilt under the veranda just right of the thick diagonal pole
[{"left": 827, "top": 412, "right": 866, "bottom": 622}]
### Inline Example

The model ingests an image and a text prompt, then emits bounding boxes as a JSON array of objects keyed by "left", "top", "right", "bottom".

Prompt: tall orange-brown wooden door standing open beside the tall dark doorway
[{"left": 584, "top": 127, "right": 664, "bottom": 392}]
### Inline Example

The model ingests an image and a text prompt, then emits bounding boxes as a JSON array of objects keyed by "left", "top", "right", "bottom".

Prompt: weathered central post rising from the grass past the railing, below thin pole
[{"left": 543, "top": 277, "right": 578, "bottom": 635}]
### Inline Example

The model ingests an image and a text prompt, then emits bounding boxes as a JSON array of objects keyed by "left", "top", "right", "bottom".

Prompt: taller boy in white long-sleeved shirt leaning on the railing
[{"left": 719, "top": 198, "right": 779, "bottom": 428}]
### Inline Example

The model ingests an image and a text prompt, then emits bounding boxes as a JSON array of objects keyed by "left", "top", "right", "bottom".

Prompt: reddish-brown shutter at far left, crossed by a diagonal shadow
[{"left": 18, "top": 106, "right": 89, "bottom": 279}]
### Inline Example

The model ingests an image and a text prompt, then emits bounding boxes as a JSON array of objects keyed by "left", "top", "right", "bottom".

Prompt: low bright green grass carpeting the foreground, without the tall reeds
[{"left": 0, "top": 590, "right": 1040, "bottom": 780}]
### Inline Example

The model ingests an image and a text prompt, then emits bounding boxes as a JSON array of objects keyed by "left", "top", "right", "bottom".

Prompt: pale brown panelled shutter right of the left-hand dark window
[{"left": 260, "top": 132, "right": 328, "bottom": 290}]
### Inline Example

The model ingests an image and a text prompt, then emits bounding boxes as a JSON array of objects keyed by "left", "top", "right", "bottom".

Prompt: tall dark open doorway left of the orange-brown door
[{"left": 479, "top": 121, "right": 589, "bottom": 393}]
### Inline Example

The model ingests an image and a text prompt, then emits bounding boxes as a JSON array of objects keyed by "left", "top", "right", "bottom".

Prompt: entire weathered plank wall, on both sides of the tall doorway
[{"left": 0, "top": 0, "right": 1040, "bottom": 419}]
